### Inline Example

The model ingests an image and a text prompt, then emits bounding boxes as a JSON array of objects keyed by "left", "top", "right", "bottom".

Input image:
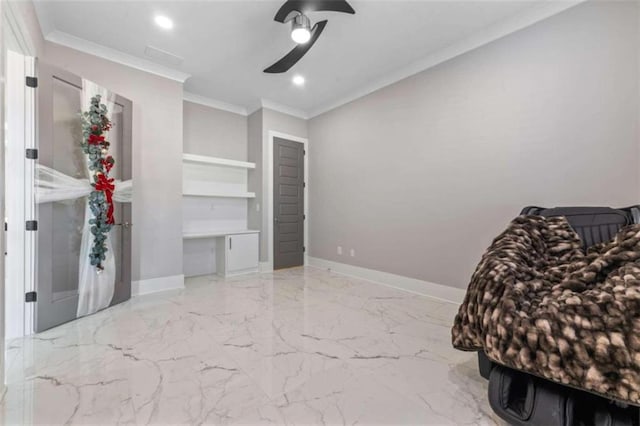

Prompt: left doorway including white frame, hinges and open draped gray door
[{"left": 3, "top": 55, "right": 132, "bottom": 339}]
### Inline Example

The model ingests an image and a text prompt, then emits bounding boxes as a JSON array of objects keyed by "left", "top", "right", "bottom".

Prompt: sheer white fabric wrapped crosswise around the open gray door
[{"left": 36, "top": 79, "right": 133, "bottom": 317}]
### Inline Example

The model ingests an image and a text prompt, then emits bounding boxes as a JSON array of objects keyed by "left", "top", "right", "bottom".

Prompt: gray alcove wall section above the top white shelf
[{"left": 183, "top": 101, "right": 247, "bottom": 161}]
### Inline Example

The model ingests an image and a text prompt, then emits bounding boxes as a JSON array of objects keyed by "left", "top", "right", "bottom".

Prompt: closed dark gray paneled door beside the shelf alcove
[{"left": 273, "top": 138, "right": 305, "bottom": 269}]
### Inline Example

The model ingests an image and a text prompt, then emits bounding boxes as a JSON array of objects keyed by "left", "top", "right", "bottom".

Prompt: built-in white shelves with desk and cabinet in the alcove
[{"left": 182, "top": 154, "right": 260, "bottom": 276}]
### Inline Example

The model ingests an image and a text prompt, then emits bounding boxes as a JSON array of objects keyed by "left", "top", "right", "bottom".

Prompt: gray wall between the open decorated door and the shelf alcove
[{"left": 40, "top": 42, "right": 183, "bottom": 280}]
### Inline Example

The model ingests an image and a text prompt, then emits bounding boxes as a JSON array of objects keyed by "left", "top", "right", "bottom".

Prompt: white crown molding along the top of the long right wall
[{"left": 305, "top": 0, "right": 586, "bottom": 118}]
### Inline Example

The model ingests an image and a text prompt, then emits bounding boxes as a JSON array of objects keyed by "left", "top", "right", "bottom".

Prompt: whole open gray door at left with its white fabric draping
[{"left": 33, "top": 62, "right": 132, "bottom": 332}]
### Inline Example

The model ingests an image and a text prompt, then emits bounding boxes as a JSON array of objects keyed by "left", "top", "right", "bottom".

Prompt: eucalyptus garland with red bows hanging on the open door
[{"left": 82, "top": 95, "right": 115, "bottom": 272}]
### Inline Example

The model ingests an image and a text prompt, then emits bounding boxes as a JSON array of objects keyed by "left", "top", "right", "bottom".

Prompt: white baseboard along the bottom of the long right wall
[{"left": 308, "top": 257, "right": 466, "bottom": 304}]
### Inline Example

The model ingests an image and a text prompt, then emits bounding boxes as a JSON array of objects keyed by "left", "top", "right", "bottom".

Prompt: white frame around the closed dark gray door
[{"left": 264, "top": 130, "right": 309, "bottom": 270}]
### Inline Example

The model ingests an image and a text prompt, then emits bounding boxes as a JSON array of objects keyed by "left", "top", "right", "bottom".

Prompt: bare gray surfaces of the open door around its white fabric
[{"left": 35, "top": 63, "right": 132, "bottom": 332}]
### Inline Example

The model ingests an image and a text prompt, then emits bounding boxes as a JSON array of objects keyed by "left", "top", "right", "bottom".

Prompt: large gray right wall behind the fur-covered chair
[{"left": 309, "top": 2, "right": 640, "bottom": 287}]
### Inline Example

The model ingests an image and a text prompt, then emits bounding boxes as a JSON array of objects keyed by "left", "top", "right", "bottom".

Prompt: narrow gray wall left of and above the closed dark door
[{"left": 248, "top": 108, "right": 308, "bottom": 262}]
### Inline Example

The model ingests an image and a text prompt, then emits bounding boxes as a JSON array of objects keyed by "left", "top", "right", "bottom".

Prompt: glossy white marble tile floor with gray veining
[{"left": 0, "top": 268, "right": 499, "bottom": 425}]
